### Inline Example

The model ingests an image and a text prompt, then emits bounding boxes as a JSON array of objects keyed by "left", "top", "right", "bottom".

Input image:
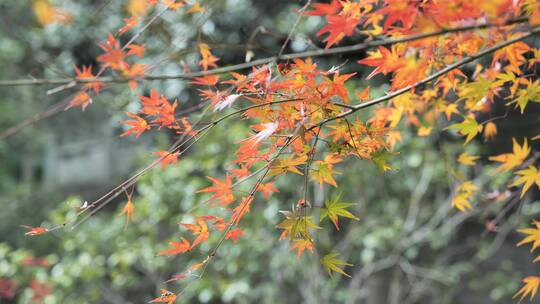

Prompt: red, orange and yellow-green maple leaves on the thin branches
[{"left": 27, "top": 0, "right": 540, "bottom": 303}]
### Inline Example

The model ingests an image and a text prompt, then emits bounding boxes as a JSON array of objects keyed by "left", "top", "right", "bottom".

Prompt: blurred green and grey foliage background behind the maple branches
[{"left": 0, "top": 0, "right": 540, "bottom": 304}]
